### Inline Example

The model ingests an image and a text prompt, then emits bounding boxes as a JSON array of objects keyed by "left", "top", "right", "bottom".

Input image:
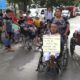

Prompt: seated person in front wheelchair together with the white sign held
[{"left": 43, "top": 24, "right": 63, "bottom": 69}]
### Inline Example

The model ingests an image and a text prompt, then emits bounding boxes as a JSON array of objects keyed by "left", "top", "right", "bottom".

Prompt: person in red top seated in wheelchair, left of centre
[{"left": 19, "top": 17, "right": 36, "bottom": 39}]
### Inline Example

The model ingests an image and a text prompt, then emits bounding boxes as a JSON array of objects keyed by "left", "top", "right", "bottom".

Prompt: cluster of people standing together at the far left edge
[{"left": 0, "top": 9, "right": 17, "bottom": 51}]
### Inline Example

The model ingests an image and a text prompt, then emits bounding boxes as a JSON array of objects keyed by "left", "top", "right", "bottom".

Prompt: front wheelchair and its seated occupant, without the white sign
[{"left": 36, "top": 23, "right": 68, "bottom": 73}]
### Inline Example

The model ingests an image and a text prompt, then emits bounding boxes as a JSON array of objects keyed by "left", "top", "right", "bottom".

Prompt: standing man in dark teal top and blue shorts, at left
[{"left": 4, "top": 9, "right": 13, "bottom": 51}]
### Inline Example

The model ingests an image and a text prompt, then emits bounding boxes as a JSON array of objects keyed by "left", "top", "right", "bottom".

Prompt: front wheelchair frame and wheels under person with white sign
[{"left": 36, "top": 34, "right": 69, "bottom": 74}]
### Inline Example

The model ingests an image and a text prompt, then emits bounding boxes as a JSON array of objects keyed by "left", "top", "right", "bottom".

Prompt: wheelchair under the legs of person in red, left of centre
[{"left": 20, "top": 24, "right": 35, "bottom": 51}]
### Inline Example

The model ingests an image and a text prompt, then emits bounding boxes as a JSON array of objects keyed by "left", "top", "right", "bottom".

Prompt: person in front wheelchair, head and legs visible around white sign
[{"left": 43, "top": 24, "right": 64, "bottom": 69}]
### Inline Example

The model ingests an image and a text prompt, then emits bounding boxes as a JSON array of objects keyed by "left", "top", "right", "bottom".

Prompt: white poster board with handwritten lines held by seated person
[{"left": 43, "top": 34, "right": 61, "bottom": 55}]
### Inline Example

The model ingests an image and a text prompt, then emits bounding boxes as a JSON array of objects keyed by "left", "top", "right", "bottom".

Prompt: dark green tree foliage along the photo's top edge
[{"left": 7, "top": 0, "right": 79, "bottom": 11}]
